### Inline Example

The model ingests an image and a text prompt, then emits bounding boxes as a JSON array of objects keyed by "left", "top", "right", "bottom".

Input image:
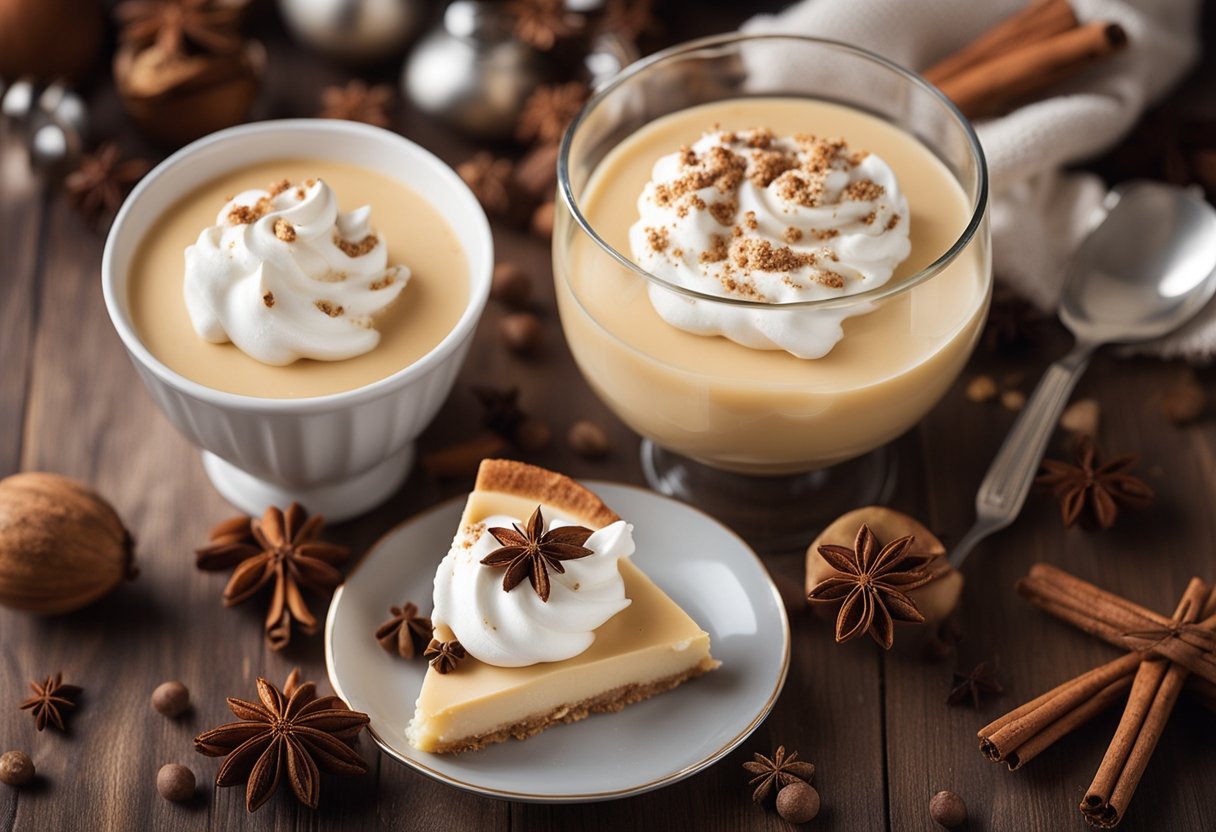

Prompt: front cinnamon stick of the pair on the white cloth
[{"left": 939, "top": 22, "right": 1127, "bottom": 118}]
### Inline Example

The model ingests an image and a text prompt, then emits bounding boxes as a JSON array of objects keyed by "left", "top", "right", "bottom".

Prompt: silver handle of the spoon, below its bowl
[{"left": 950, "top": 342, "right": 1097, "bottom": 569}]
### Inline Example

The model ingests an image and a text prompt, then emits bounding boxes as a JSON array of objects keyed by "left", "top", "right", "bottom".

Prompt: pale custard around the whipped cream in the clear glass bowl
[{"left": 554, "top": 99, "right": 991, "bottom": 473}]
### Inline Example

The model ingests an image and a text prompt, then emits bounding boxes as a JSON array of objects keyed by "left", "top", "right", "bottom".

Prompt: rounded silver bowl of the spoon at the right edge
[{"left": 1059, "top": 182, "right": 1216, "bottom": 343}]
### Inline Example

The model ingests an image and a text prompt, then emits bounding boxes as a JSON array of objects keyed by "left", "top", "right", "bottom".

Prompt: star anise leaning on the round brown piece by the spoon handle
[{"left": 807, "top": 523, "right": 933, "bottom": 650}]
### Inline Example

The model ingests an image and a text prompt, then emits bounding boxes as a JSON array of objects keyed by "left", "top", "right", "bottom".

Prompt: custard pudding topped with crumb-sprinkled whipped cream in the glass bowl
[{"left": 554, "top": 97, "right": 991, "bottom": 474}]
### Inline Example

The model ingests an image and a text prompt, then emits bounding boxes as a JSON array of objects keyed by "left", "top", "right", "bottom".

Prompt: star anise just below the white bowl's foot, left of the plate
[{"left": 196, "top": 502, "right": 350, "bottom": 650}]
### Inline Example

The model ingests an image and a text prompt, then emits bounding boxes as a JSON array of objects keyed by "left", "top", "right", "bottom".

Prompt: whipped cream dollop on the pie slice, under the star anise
[{"left": 430, "top": 515, "right": 634, "bottom": 668}]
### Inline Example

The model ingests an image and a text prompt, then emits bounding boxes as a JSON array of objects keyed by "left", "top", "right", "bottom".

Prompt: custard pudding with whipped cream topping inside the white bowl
[{"left": 128, "top": 158, "right": 469, "bottom": 399}]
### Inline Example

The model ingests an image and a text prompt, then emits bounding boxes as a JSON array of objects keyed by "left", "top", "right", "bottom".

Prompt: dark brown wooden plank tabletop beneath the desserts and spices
[{"left": 0, "top": 2, "right": 1216, "bottom": 832}]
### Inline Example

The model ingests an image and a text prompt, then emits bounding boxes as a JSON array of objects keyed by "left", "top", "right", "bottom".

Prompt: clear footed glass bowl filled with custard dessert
[{"left": 553, "top": 34, "right": 992, "bottom": 549}]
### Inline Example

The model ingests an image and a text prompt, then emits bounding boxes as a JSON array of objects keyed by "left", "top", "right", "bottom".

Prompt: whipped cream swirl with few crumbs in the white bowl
[{"left": 184, "top": 179, "right": 410, "bottom": 365}]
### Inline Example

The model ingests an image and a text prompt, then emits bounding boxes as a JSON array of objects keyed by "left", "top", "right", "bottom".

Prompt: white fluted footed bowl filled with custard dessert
[{"left": 101, "top": 119, "right": 494, "bottom": 521}]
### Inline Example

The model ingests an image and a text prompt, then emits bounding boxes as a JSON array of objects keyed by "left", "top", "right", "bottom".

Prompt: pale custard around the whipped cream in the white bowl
[{"left": 128, "top": 159, "right": 469, "bottom": 398}]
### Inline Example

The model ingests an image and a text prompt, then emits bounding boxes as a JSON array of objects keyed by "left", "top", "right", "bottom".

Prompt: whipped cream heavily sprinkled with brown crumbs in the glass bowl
[{"left": 629, "top": 129, "right": 911, "bottom": 359}]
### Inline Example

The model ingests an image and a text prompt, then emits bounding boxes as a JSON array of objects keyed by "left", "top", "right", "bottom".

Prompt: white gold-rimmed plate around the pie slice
[{"left": 325, "top": 482, "right": 789, "bottom": 803}]
